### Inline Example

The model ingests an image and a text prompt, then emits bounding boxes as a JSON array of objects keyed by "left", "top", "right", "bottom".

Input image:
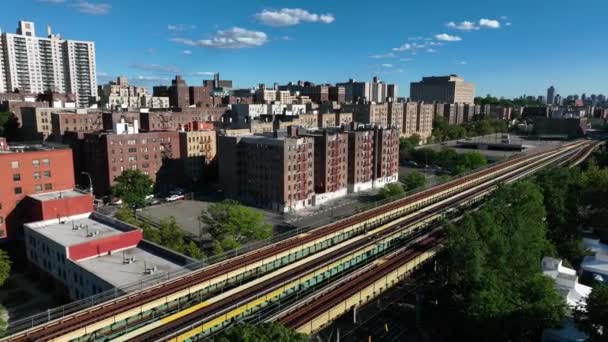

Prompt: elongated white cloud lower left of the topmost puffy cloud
[{"left": 171, "top": 27, "right": 268, "bottom": 49}]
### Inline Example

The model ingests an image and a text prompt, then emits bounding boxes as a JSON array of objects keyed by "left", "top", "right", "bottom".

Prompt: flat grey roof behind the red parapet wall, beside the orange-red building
[{"left": 26, "top": 213, "right": 123, "bottom": 246}]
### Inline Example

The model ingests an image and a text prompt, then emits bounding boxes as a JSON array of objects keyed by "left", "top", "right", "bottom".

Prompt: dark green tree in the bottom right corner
[{"left": 574, "top": 284, "right": 608, "bottom": 341}]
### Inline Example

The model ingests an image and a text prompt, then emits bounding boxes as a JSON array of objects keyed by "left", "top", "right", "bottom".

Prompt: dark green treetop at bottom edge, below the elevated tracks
[{"left": 216, "top": 323, "right": 309, "bottom": 342}]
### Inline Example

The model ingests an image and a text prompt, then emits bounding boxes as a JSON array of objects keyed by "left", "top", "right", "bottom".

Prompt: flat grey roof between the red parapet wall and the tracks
[{"left": 77, "top": 247, "right": 183, "bottom": 287}]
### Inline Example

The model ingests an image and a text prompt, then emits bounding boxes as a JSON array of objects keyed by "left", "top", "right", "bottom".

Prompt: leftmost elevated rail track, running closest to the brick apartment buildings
[{"left": 2, "top": 141, "right": 584, "bottom": 341}]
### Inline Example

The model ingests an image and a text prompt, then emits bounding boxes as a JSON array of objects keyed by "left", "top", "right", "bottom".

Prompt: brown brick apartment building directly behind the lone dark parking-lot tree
[{"left": 74, "top": 125, "right": 180, "bottom": 196}]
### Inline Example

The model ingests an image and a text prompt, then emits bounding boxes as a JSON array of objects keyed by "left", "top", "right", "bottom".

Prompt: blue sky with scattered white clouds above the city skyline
[{"left": 0, "top": 0, "right": 608, "bottom": 97}]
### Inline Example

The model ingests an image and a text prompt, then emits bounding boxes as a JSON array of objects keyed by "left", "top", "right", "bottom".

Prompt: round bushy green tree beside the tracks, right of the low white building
[{"left": 199, "top": 200, "right": 272, "bottom": 250}]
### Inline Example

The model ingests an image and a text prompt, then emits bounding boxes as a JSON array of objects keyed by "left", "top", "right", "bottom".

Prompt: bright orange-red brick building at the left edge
[{"left": 0, "top": 138, "right": 85, "bottom": 239}]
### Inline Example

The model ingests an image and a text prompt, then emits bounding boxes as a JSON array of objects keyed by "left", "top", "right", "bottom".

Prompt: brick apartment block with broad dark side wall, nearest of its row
[{"left": 218, "top": 127, "right": 315, "bottom": 212}]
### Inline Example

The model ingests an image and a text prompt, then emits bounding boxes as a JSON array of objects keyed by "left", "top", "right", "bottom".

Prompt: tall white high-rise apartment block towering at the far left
[{"left": 0, "top": 21, "right": 97, "bottom": 106}]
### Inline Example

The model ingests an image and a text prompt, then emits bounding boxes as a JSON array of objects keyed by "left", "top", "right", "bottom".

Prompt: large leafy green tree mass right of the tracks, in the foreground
[{"left": 434, "top": 182, "right": 565, "bottom": 341}]
